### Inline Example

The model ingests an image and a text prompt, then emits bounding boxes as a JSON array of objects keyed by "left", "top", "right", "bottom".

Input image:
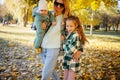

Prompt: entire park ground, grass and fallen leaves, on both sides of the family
[{"left": 0, "top": 25, "right": 120, "bottom": 80}]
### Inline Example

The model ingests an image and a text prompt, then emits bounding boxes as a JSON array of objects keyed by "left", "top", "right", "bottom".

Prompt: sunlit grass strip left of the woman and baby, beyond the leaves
[{"left": 0, "top": 26, "right": 35, "bottom": 44}]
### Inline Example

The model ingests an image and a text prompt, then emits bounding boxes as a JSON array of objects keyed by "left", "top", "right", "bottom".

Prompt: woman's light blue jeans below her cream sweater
[{"left": 40, "top": 48, "right": 60, "bottom": 80}]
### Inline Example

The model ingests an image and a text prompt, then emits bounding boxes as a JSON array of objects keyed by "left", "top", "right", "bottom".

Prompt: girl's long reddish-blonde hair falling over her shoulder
[{"left": 65, "top": 16, "right": 88, "bottom": 44}]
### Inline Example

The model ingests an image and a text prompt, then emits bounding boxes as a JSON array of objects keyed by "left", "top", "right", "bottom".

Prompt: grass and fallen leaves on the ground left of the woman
[{"left": 0, "top": 26, "right": 42, "bottom": 80}]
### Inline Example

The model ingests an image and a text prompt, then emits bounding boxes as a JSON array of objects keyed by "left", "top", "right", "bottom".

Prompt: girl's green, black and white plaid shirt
[{"left": 62, "top": 32, "right": 80, "bottom": 73}]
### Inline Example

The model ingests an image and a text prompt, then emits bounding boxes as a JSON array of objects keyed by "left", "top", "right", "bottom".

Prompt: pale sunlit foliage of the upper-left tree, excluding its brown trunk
[{"left": 5, "top": 0, "right": 28, "bottom": 23}]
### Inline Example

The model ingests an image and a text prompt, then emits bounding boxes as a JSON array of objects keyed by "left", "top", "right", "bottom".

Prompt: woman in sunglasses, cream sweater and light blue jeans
[{"left": 40, "top": 0, "right": 70, "bottom": 80}]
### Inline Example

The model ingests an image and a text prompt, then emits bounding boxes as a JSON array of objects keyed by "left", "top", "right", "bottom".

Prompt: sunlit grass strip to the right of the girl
[{"left": 86, "top": 31, "right": 120, "bottom": 51}]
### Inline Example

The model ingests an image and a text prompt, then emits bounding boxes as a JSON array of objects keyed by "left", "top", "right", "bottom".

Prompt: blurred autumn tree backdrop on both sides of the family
[{"left": 0, "top": 0, "right": 120, "bottom": 34}]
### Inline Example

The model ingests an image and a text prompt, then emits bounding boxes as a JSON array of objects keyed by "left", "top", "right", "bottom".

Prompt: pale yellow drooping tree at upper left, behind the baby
[{"left": 5, "top": 0, "right": 38, "bottom": 26}]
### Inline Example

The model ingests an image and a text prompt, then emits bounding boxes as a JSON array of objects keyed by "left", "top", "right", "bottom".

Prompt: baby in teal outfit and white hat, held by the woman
[{"left": 32, "top": 0, "right": 56, "bottom": 53}]
